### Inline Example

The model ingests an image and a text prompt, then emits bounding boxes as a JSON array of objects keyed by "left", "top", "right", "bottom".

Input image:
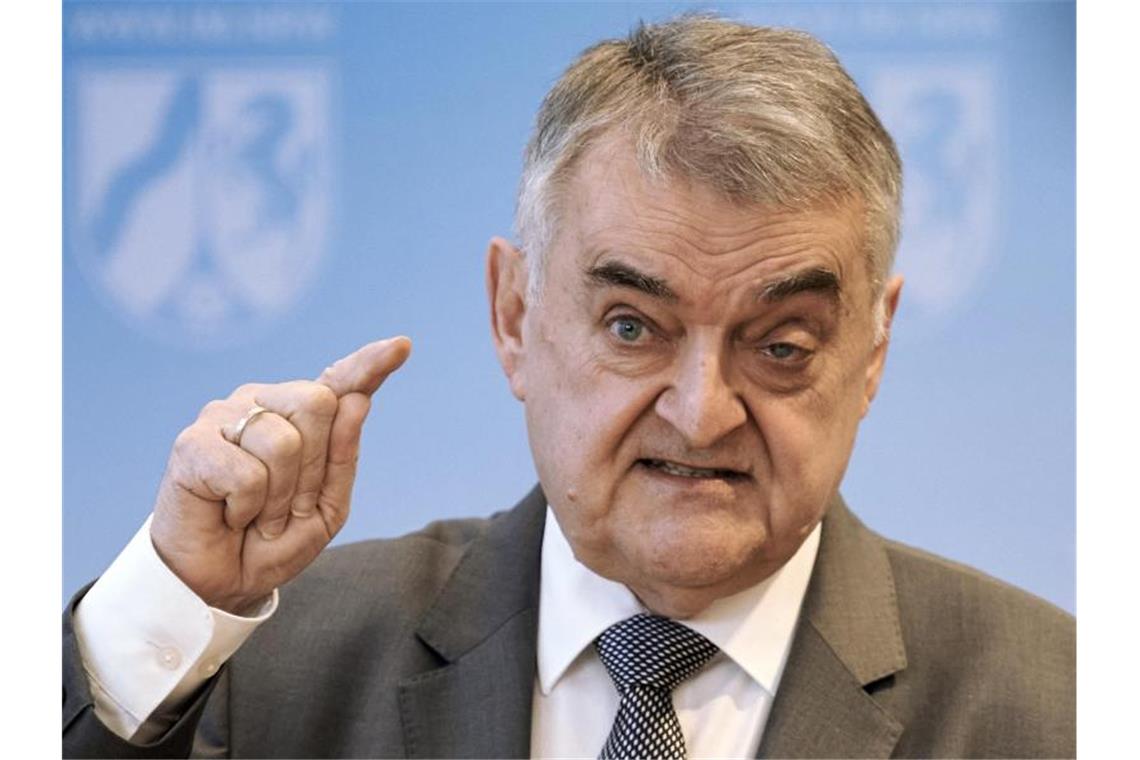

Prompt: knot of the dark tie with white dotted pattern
[{"left": 594, "top": 613, "right": 718, "bottom": 693}]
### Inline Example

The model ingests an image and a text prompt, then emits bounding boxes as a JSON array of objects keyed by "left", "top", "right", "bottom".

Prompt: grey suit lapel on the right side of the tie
[{"left": 759, "top": 497, "right": 906, "bottom": 758}]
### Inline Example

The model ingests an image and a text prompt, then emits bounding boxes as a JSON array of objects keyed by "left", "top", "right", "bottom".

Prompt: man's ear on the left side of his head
[{"left": 487, "top": 237, "right": 527, "bottom": 401}]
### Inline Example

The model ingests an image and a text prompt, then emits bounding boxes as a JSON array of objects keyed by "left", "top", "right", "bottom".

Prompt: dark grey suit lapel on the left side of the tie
[{"left": 399, "top": 488, "right": 546, "bottom": 758}]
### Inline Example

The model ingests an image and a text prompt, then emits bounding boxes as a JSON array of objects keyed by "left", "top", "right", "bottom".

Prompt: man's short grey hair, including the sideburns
[{"left": 515, "top": 15, "right": 902, "bottom": 333}]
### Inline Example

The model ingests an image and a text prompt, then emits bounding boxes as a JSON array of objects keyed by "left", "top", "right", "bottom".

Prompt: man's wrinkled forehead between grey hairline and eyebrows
[{"left": 555, "top": 141, "right": 865, "bottom": 280}]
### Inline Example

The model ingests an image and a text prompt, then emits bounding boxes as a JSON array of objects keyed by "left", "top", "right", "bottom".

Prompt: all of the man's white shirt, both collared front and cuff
[{"left": 74, "top": 508, "right": 820, "bottom": 758}]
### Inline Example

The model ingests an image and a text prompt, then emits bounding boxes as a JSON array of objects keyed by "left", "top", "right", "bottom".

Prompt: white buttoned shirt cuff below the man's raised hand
[{"left": 74, "top": 517, "right": 277, "bottom": 741}]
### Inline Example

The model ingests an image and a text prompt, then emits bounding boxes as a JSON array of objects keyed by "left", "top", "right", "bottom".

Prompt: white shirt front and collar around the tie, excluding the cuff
[{"left": 530, "top": 507, "right": 820, "bottom": 758}]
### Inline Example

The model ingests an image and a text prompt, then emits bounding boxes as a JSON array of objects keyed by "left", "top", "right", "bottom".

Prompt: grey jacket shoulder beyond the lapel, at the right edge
[{"left": 879, "top": 540, "right": 1076, "bottom": 757}]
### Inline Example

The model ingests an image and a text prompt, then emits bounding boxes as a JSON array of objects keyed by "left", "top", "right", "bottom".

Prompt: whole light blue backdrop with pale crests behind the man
[{"left": 63, "top": 2, "right": 1075, "bottom": 611}]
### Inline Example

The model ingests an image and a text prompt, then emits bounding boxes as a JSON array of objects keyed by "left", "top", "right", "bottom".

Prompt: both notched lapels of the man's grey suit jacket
[{"left": 400, "top": 488, "right": 906, "bottom": 758}]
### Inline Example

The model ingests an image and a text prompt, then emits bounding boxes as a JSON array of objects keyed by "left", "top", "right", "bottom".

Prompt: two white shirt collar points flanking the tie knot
[{"left": 538, "top": 506, "right": 820, "bottom": 695}]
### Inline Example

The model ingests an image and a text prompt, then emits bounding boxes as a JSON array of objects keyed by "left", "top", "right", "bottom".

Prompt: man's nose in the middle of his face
[{"left": 654, "top": 341, "right": 748, "bottom": 449}]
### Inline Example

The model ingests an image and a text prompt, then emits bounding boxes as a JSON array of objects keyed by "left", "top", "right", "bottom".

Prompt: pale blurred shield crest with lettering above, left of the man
[{"left": 68, "top": 5, "right": 336, "bottom": 349}]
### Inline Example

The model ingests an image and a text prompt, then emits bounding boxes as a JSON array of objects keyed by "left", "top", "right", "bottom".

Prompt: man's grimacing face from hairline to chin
[{"left": 490, "top": 145, "right": 901, "bottom": 616}]
